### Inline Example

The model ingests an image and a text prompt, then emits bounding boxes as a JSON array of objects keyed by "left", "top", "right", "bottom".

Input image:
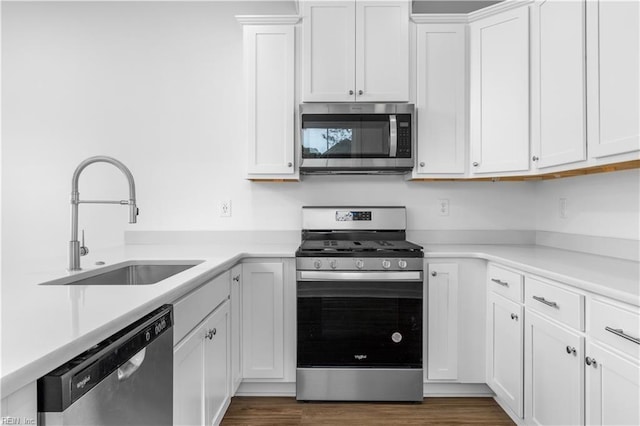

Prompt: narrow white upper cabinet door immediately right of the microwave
[{"left": 415, "top": 24, "right": 466, "bottom": 176}]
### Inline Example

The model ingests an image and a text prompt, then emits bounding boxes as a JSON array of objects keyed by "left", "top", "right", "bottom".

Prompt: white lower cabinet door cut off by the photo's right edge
[{"left": 585, "top": 343, "right": 640, "bottom": 425}]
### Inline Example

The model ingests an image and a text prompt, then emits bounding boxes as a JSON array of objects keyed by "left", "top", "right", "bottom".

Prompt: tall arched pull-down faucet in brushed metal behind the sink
[{"left": 69, "top": 155, "right": 138, "bottom": 271}]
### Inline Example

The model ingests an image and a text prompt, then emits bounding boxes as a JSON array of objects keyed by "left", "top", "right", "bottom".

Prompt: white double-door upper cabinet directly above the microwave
[{"left": 302, "top": 0, "right": 409, "bottom": 102}]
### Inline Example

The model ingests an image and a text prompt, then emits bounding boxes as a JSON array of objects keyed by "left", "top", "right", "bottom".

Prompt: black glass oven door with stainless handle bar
[{"left": 297, "top": 271, "right": 423, "bottom": 368}]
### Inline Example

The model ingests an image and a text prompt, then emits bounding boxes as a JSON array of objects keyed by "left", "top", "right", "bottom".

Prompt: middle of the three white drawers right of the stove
[{"left": 525, "top": 277, "right": 584, "bottom": 331}]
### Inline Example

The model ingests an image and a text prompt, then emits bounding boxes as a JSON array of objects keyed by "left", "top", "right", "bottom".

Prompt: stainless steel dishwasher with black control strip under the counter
[{"left": 38, "top": 305, "right": 173, "bottom": 426}]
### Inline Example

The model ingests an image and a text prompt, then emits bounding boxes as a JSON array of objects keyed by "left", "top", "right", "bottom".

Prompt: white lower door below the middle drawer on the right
[{"left": 524, "top": 309, "right": 584, "bottom": 425}]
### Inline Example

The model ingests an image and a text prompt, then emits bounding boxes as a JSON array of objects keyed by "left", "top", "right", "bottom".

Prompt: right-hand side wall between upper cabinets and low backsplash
[{"left": 535, "top": 170, "right": 640, "bottom": 240}]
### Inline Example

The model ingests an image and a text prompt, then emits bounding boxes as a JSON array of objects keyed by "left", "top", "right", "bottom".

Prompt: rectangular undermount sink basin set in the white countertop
[{"left": 41, "top": 260, "right": 203, "bottom": 285}]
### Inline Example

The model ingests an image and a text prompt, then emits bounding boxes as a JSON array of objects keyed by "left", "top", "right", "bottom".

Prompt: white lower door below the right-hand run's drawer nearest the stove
[{"left": 487, "top": 293, "right": 524, "bottom": 418}]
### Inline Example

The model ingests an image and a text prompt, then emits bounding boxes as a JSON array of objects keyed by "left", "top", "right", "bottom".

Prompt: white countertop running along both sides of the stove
[{"left": 0, "top": 241, "right": 640, "bottom": 397}]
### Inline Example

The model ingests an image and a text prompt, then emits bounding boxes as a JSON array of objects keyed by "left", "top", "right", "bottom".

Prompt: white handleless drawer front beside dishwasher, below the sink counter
[{"left": 173, "top": 271, "right": 230, "bottom": 345}]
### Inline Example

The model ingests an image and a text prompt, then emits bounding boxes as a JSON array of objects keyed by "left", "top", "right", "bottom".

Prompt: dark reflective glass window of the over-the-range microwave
[{"left": 302, "top": 114, "right": 389, "bottom": 158}]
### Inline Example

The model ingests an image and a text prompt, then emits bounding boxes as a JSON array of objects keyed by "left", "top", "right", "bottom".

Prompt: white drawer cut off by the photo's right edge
[{"left": 588, "top": 299, "right": 640, "bottom": 359}]
